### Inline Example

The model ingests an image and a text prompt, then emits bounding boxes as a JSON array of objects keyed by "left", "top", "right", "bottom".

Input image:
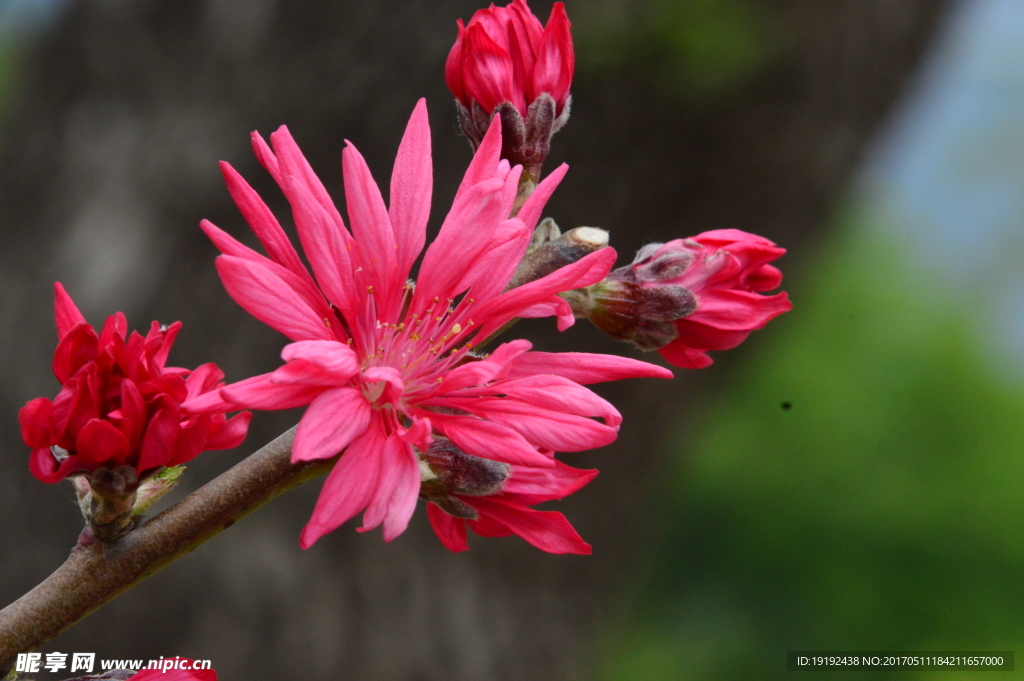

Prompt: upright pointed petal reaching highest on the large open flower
[{"left": 388, "top": 99, "right": 434, "bottom": 283}]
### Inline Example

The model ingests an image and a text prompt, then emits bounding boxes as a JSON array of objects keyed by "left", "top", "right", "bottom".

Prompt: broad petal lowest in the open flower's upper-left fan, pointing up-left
[{"left": 216, "top": 255, "right": 334, "bottom": 340}]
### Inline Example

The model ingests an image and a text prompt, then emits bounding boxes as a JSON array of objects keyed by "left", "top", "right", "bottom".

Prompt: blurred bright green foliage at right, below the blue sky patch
[{"left": 600, "top": 219, "right": 1024, "bottom": 681}]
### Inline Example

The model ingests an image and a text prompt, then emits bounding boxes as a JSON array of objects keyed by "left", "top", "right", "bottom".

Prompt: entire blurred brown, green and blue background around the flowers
[{"left": 0, "top": 0, "right": 1024, "bottom": 681}]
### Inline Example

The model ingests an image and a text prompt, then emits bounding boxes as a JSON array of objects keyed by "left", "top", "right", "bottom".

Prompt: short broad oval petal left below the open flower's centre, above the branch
[{"left": 292, "top": 388, "right": 371, "bottom": 464}]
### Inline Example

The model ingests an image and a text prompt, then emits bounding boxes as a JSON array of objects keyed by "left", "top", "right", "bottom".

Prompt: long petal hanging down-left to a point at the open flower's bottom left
[{"left": 299, "top": 424, "right": 385, "bottom": 549}]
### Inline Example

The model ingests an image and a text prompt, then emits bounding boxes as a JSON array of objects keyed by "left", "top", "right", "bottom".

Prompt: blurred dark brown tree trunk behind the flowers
[{"left": 0, "top": 0, "right": 944, "bottom": 681}]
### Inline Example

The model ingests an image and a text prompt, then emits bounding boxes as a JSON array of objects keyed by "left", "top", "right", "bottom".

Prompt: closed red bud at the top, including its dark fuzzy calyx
[{"left": 444, "top": 0, "right": 575, "bottom": 184}]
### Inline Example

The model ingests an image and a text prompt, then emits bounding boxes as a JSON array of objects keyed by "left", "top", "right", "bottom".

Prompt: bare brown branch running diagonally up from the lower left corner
[{"left": 0, "top": 428, "right": 327, "bottom": 678}]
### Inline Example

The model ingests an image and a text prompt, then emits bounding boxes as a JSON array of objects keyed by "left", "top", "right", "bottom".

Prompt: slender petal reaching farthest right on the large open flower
[{"left": 508, "top": 352, "right": 672, "bottom": 384}]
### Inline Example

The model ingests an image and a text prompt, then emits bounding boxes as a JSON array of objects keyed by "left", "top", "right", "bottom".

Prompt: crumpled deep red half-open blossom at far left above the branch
[{"left": 18, "top": 283, "right": 251, "bottom": 482}]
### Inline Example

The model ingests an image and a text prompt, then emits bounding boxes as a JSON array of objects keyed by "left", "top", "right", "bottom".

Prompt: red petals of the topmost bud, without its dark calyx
[{"left": 444, "top": 0, "right": 575, "bottom": 118}]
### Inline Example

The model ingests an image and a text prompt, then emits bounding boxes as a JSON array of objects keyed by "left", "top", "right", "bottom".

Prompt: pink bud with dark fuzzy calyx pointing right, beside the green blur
[{"left": 569, "top": 229, "right": 793, "bottom": 369}]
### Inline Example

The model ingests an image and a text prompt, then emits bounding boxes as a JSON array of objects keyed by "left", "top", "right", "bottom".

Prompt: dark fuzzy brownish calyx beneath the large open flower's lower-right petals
[{"left": 420, "top": 437, "right": 512, "bottom": 520}]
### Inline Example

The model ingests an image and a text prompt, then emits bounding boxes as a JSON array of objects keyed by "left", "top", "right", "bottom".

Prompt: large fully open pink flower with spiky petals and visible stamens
[{"left": 186, "top": 100, "right": 671, "bottom": 547}]
